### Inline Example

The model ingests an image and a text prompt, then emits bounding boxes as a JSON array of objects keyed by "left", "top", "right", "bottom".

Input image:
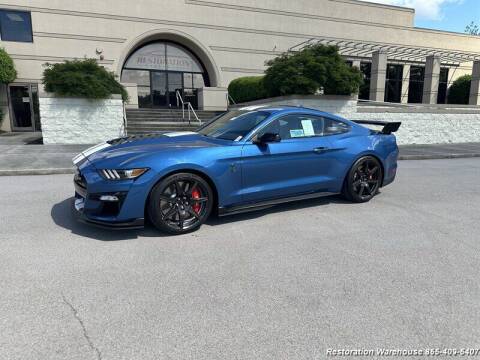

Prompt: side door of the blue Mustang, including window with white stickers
[{"left": 242, "top": 114, "right": 334, "bottom": 202}]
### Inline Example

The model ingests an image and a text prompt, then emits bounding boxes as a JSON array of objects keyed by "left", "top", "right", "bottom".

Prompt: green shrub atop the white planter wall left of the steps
[{"left": 43, "top": 59, "right": 128, "bottom": 101}]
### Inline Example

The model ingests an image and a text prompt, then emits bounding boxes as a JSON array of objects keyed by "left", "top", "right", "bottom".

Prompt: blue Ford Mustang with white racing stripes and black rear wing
[{"left": 74, "top": 106, "right": 400, "bottom": 234}]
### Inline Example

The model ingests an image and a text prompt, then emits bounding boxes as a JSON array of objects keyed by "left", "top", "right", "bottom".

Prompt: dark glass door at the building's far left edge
[{"left": 9, "top": 85, "right": 35, "bottom": 131}]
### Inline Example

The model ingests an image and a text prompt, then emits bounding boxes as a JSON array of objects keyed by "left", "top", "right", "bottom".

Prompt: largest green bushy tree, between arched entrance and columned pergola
[{"left": 264, "top": 45, "right": 363, "bottom": 96}]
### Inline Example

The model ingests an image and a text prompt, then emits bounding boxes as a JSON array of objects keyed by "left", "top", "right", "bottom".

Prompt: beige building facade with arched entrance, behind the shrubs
[{"left": 0, "top": 0, "right": 480, "bottom": 131}]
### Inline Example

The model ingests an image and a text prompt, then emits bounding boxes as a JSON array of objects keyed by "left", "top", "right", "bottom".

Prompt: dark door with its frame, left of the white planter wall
[{"left": 8, "top": 84, "right": 40, "bottom": 131}]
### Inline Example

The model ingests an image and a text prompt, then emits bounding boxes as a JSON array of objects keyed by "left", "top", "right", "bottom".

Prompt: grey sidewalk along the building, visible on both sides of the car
[{"left": 0, "top": 142, "right": 480, "bottom": 176}]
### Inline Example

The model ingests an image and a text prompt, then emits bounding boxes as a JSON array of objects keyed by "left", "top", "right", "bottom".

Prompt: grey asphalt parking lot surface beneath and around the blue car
[{"left": 0, "top": 158, "right": 480, "bottom": 360}]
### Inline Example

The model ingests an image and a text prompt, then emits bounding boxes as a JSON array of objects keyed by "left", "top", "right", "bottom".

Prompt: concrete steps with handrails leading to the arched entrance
[{"left": 127, "top": 109, "right": 219, "bottom": 135}]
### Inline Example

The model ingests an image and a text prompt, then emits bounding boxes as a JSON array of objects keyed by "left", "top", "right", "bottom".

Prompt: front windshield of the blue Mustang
[{"left": 198, "top": 110, "right": 271, "bottom": 141}]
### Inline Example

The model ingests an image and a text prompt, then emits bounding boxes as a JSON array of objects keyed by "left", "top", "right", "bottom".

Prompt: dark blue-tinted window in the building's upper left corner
[{"left": 0, "top": 10, "right": 33, "bottom": 42}]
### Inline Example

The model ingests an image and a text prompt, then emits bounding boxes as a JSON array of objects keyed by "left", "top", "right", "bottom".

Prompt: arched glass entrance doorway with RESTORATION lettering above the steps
[{"left": 121, "top": 41, "right": 210, "bottom": 108}]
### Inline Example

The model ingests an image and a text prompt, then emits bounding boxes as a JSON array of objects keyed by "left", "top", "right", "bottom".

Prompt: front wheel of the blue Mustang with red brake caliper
[{"left": 147, "top": 173, "right": 214, "bottom": 235}]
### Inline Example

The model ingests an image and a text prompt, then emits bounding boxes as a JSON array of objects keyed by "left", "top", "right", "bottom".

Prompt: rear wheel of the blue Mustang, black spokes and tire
[{"left": 342, "top": 156, "right": 383, "bottom": 203}]
